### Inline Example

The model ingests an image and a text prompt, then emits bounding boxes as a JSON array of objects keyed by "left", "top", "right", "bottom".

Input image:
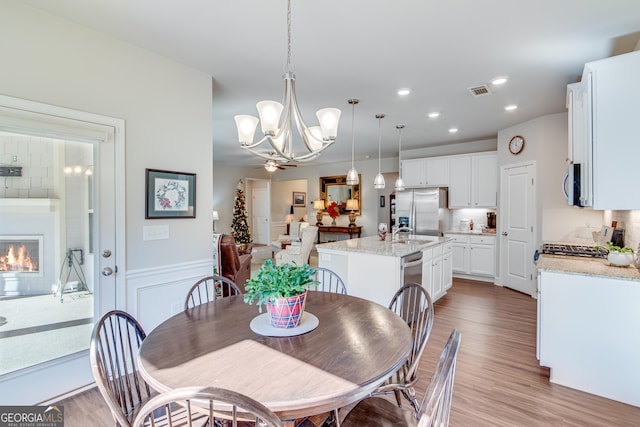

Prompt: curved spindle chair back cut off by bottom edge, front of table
[{"left": 133, "top": 387, "right": 282, "bottom": 427}]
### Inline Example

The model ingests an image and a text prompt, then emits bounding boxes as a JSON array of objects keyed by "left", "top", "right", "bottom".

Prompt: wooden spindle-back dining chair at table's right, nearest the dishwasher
[{"left": 372, "top": 283, "right": 434, "bottom": 411}]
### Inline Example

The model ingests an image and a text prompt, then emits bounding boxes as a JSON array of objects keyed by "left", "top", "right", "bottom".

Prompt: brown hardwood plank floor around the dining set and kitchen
[{"left": 56, "top": 279, "right": 640, "bottom": 427}]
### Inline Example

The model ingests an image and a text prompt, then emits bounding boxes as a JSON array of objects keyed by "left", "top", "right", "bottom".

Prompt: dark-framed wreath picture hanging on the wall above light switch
[{"left": 145, "top": 168, "right": 196, "bottom": 219}]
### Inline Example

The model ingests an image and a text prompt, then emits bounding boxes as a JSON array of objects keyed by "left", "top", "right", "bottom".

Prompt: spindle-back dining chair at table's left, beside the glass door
[{"left": 89, "top": 310, "right": 152, "bottom": 427}]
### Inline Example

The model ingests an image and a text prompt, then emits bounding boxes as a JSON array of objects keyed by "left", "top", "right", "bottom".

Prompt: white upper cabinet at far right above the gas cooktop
[{"left": 567, "top": 51, "right": 640, "bottom": 210}]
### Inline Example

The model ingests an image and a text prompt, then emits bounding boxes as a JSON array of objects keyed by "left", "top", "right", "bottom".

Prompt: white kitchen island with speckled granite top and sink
[{"left": 316, "top": 235, "right": 452, "bottom": 307}]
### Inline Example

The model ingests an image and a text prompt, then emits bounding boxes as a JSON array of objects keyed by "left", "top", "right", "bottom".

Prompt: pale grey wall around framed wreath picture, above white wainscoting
[{"left": 0, "top": 2, "right": 212, "bottom": 269}]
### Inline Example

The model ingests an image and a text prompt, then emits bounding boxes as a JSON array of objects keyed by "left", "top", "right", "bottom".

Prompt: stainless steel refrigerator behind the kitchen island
[{"left": 396, "top": 188, "right": 447, "bottom": 236}]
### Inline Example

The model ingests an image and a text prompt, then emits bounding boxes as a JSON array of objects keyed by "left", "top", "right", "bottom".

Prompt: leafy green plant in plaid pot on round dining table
[{"left": 244, "top": 259, "right": 318, "bottom": 328}]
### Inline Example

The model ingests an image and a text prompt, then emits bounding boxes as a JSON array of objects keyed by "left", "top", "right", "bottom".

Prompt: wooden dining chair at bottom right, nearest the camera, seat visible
[{"left": 342, "top": 329, "right": 462, "bottom": 427}]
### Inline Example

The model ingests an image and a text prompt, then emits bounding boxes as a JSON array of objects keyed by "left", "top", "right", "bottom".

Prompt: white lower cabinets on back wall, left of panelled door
[{"left": 445, "top": 233, "right": 496, "bottom": 282}]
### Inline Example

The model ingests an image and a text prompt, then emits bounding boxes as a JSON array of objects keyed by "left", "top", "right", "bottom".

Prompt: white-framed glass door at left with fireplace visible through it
[{"left": 0, "top": 96, "right": 125, "bottom": 405}]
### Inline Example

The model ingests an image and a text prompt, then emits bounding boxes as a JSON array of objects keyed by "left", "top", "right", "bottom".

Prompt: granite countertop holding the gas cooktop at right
[{"left": 536, "top": 254, "right": 640, "bottom": 282}]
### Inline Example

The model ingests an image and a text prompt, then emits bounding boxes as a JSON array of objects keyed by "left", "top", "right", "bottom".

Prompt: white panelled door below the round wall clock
[{"left": 498, "top": 163, "right": 536, "bottom": 296}]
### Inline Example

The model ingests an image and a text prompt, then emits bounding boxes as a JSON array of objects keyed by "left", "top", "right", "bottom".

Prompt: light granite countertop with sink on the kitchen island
[{"left": 316, "top": 234, "right": 452, "bottom": 257}]
